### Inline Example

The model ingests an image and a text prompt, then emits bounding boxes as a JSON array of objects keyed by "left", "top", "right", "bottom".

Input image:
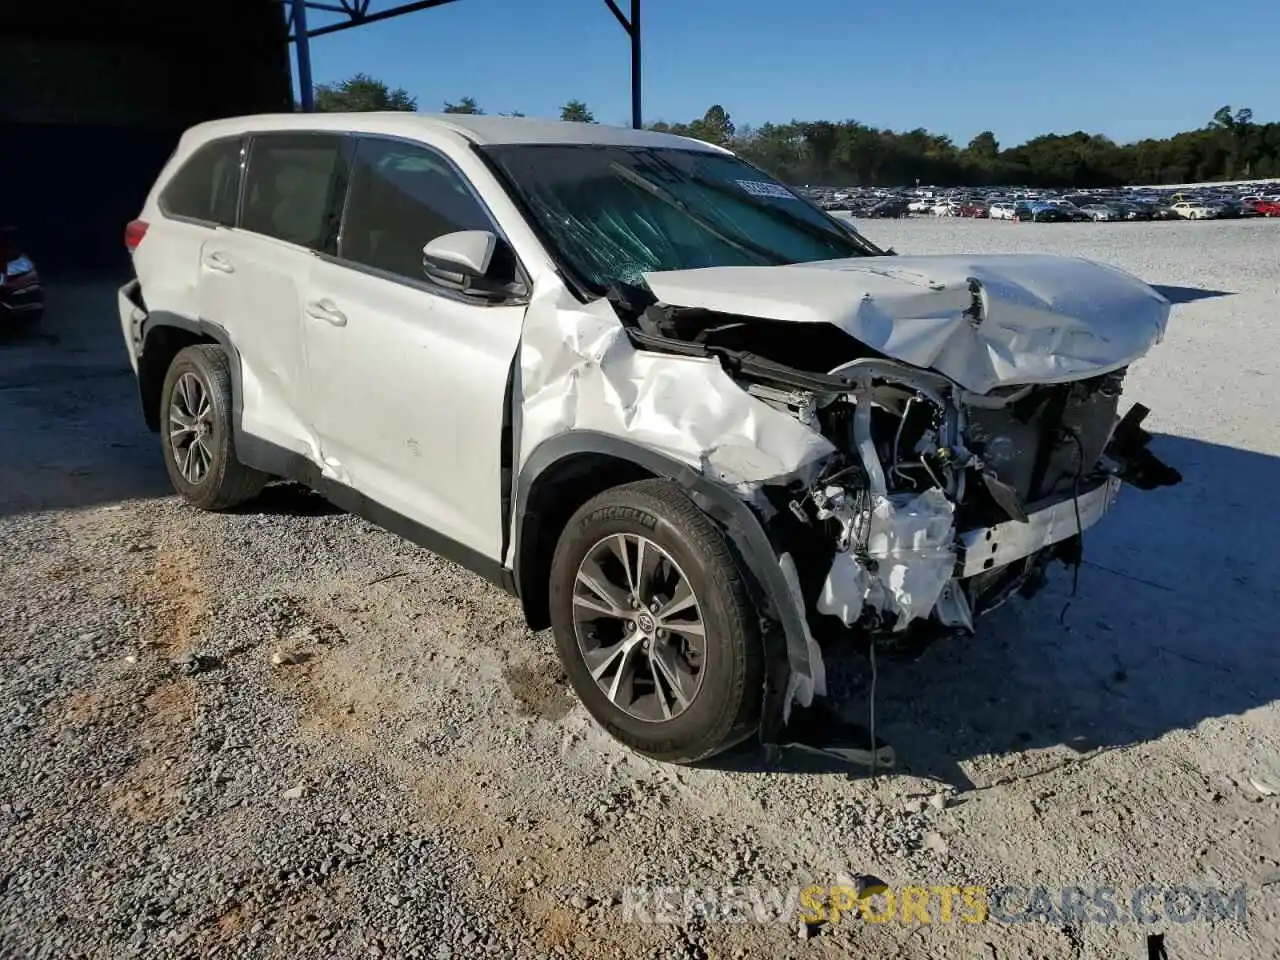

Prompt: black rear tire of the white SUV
[{"left": 160, "top": 343, "right": 270, "bottom": 511}]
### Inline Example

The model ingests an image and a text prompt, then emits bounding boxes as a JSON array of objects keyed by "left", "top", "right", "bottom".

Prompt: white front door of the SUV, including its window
[{"left": 305, "top": 131, "right": 525, "bottom": 561}]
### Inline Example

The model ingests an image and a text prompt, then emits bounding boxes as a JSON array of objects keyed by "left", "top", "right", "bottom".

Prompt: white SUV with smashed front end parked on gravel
[{"left": 119, "top": 113, "right": 1176, "bottom": 760}]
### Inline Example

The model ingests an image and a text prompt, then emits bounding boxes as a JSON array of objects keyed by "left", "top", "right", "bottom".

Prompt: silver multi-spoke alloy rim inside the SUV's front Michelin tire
[{"left": 573, "top": 534, "right": 707, "bottom": 722}]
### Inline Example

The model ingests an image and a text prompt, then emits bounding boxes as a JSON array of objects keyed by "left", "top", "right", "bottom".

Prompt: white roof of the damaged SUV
[{"left": 180, "top": 111, "right": 727, "bottom": 152}]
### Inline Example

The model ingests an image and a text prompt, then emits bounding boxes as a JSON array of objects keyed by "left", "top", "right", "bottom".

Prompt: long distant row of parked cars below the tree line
[{"left": 808, "top": 188, "right": 1280, "bottom": 223}]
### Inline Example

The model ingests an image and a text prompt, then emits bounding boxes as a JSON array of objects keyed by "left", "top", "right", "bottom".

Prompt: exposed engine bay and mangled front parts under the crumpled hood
[{"left": 616, "top": 303, "right": 1180, "bottom": 652}]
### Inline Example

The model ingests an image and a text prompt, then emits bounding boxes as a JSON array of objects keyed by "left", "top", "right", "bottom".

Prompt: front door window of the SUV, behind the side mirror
[{"left": 339, "top": 137, "right": 495, "bottom": 280}]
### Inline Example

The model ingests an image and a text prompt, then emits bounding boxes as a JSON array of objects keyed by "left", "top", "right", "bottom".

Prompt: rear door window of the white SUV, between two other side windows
[{"left": 241, "top": 133, "right": 349, "bottom": 253}]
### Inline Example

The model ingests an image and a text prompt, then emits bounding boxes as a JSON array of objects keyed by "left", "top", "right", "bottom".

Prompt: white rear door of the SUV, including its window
[{"left": 198, "top": 133, "right": 353, "bottom": 460}]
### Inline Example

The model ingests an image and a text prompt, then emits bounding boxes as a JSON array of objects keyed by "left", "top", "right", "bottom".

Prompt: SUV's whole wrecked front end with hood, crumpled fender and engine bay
[{"left": 516, "top": 249, "right": 1180, "bottom": 739}]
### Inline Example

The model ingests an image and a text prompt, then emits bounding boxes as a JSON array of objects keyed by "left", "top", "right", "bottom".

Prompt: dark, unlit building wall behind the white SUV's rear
[{"left": 0, "top": 0, "right": 293, "bottom": 271}]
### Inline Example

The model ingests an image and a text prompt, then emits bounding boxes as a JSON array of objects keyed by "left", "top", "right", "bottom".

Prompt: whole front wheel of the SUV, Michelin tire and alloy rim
[{"left": 550, "top": 480, "right": 764, "bottom": 763}]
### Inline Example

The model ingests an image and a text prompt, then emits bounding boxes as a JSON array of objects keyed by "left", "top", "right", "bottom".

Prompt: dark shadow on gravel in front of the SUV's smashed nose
[{"left": 712, "top": 435, "right": 1280, "bottom": 790}]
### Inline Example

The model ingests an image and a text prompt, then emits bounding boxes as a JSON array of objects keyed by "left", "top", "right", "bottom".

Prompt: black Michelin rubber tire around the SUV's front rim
[{"left": 549, "top": 480, "right": 764, "bottom": 763}]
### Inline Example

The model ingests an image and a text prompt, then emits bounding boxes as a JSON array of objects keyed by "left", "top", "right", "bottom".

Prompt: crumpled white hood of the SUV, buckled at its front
[{"left": 644, "top": 253, "right": 1169, "bottom": 393}]
